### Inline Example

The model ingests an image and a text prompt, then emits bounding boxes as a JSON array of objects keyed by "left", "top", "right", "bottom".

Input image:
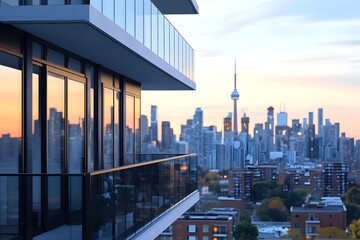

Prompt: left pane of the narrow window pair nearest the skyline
[{"left": 125, "top": 95, "right": 135, "bottom": 165}]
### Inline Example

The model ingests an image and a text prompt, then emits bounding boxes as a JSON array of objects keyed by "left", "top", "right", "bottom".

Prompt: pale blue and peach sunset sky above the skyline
[{"left": 141, "top": 0, "right": 360, "bottom": 139}]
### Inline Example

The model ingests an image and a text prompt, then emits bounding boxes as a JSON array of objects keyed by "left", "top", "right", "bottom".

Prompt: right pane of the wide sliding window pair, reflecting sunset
[{"left": 68, "top": 79, "right": 85, "bottom": 173}]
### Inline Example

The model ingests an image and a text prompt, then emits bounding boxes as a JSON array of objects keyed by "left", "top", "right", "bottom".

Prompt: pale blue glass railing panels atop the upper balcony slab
[{"left": 0, "top": 0, "right": 194, "bottom": 80}]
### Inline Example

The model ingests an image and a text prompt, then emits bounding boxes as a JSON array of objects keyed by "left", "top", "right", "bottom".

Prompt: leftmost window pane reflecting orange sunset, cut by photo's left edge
[{"left": 0, "top": 51, "right": 22, "bottom": 173}]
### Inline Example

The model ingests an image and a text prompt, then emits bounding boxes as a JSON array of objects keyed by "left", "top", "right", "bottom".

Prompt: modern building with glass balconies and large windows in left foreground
[{"left": 0, "top": 0, "right": 199, "bottom": 239}]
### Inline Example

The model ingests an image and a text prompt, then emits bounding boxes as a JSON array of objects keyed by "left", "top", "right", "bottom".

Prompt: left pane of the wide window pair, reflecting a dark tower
[{"left": 47, "top": 72, "right": 65, "bottom": 173}]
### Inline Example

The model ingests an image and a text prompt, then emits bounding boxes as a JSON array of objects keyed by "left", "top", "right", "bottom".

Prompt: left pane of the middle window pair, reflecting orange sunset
[{"left": 103, "top": 88, "right": 114, "bottom": 169}]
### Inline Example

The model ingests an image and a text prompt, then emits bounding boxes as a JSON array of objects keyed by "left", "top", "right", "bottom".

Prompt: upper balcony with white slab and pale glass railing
[{"left": 0, "top": 0, "right": 197, "bottom": 90}]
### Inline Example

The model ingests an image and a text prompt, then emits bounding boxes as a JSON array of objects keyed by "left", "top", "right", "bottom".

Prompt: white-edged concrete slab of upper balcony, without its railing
[{"left": 0, "top": 5, "right": 196, "bottom": 90}]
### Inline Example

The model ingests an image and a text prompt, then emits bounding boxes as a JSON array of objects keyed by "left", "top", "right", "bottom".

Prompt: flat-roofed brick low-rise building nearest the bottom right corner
[{"left": 290, "top": 197, "right": 347, "bottom": 239}]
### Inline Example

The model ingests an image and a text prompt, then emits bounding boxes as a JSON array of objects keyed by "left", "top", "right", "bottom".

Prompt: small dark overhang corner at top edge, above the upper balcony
[{"left": 151, "top": 0, "right": 199, "bottom": 14}]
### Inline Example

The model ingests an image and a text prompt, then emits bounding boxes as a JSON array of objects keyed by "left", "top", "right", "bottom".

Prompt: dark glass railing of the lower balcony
[{"left": 0, "top": 154, "right": 197, "bottom": 240}]
